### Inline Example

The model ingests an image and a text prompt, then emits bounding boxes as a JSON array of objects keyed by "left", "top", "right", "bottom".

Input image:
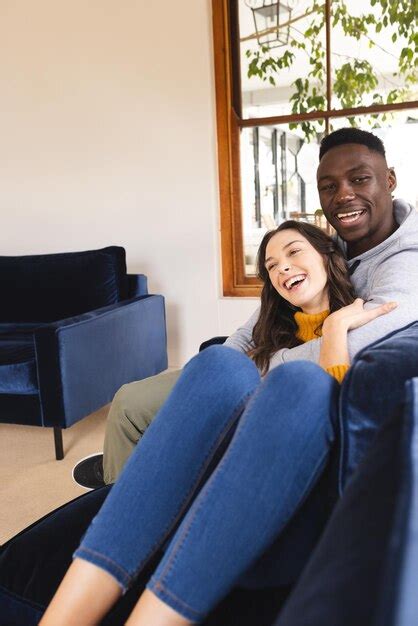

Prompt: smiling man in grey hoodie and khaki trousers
[{"left": 99, "top": 128, "right": 418, "bottom": 483}]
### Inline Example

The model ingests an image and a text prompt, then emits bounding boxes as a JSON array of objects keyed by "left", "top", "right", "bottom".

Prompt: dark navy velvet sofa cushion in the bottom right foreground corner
[{"left": 275, "top": 379, "right": 418, "bottom": 626}]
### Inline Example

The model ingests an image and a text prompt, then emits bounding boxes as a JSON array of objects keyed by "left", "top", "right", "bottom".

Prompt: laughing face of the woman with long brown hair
[{"left": 265, "top": 229, "right": 329, "bottom": 313}]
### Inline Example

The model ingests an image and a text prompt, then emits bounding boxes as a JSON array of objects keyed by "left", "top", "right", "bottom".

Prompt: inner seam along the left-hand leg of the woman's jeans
[{"left": 130, "top": 392, "right": 254, "bottom": 582}]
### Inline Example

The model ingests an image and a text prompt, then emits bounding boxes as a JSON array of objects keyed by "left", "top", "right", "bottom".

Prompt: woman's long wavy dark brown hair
[{"left": 248, "top": 220, "right": 355, "bottom": 374}]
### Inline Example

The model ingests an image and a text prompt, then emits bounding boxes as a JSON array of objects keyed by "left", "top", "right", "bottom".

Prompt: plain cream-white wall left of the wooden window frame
[{"left": 0, "top": 0, "right": 257, "bottom": 365}]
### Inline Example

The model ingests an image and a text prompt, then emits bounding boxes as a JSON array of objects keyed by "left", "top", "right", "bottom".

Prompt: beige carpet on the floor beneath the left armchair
[{"left": 0, "top": 407, "right": 109, "bottom": 544}]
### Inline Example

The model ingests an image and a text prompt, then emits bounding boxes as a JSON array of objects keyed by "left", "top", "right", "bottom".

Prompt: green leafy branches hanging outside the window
[{"left": 246, "top": 0, "right": 418, "bottom": 140}]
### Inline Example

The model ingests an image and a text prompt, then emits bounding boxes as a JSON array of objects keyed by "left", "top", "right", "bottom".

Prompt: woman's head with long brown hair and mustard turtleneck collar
[{"left": 247, "top": 220, "right": 355, "bottom": 373}]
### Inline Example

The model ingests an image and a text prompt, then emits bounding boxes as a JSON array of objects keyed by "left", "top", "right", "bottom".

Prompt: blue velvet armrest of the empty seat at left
[{"left": 34, "top": 295, "right": 167, "bottom": 428}]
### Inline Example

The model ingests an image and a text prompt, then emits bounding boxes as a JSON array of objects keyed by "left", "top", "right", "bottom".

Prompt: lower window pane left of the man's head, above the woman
[{"left": 241, "top": 124, "right": 325, "bottom": 276}]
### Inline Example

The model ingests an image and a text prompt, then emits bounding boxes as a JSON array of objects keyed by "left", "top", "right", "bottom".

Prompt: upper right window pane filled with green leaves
[{"left": 331, "top": 0, "right": 418, "bottom": 109}]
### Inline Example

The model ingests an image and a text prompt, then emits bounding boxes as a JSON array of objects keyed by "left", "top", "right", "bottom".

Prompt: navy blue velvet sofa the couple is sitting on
[{"left": 0, "top": 322, "right": 418, "bottom": 626}]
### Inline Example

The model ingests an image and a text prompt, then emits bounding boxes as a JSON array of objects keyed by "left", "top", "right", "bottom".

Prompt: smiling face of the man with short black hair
[{"left": 317, "top": 143, "right": 396, "bottom": 258}]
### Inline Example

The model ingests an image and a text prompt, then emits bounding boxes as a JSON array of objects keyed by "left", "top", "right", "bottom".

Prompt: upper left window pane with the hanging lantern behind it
[{"left": 238, "top": 0, "right": 326, "bottom": 118}]
